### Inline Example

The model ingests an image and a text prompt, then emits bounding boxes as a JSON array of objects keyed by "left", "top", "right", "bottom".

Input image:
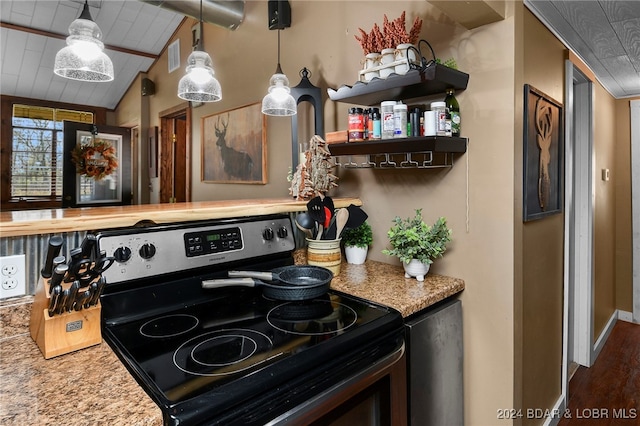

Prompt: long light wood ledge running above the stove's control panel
[{"left": 0, "top": 198, "right": 362, "bottom": 237}]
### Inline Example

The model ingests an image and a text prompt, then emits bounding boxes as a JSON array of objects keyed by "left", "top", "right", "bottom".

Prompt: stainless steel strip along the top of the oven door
[{"left": 265, "top": 339, "right": 406, "bottom": 426}]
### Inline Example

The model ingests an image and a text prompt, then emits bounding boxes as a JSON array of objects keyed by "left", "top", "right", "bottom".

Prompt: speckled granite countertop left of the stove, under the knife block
[{"left": 0, "top": 296, "right": 162, "bottom": 426}]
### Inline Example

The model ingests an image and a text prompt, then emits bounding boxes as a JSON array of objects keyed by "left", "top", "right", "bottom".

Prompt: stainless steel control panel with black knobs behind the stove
[{"left": 96, "top": 215, "right": 295, "bottom": 285}]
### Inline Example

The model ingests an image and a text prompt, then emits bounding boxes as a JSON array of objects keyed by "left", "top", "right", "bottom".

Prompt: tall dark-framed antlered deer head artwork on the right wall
[{"left": 523, "top": 84, "right": 564, "bottom": 222}]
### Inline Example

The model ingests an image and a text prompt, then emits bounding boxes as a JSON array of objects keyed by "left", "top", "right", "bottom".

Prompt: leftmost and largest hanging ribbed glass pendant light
[{"left": 53, "top": 0, "right": 113, "bottom": 82}]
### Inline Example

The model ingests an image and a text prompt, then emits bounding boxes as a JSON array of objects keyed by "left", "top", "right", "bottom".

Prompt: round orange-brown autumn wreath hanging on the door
[{"left": 71, "top": 139, "right": 118, "bottom": 180}]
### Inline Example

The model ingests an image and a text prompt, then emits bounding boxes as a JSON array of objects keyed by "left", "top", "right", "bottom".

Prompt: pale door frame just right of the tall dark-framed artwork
[{"left": 562, "top": 60, "right": 595, "bottom": 403}]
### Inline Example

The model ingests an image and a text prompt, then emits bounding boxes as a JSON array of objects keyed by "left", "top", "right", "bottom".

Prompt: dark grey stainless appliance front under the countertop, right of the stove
[{"left": 405, "top": 300, "right": 464, "bottom": 426}]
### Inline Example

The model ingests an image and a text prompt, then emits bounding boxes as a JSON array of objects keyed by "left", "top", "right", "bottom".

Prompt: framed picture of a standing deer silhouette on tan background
[{"left": 201, "top": 103, "right": 267, "bottom": 184}]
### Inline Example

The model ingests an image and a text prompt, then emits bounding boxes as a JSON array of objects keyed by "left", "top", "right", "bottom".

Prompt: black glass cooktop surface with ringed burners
[{"left": 103, "top": 282, "right": 402, "bottom": 424}]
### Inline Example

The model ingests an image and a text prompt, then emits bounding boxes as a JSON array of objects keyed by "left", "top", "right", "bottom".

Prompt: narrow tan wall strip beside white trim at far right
[{"left": 611, "top": 98, "right": 639, "bottom": 312}]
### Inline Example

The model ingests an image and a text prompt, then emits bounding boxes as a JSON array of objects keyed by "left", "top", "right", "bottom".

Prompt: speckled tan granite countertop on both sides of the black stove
[{"left": 0, "top": 253, "right": 464, "bottom": 425}]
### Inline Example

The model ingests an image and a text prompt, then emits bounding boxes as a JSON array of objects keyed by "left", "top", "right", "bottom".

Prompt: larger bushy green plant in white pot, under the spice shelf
[{"left": 382, "top": 209, "right": 451, "bottom": 281}]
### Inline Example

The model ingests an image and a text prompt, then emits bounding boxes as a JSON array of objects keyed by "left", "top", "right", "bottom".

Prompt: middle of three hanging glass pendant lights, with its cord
[{"left": 178, "top": 0, "right": 222, "bottom": 102}]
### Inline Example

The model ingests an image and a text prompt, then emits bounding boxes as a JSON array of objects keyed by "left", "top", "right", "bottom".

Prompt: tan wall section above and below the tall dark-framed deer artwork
[{"left": 514, "top": 9, "right": 565, "bottom": 424}]
